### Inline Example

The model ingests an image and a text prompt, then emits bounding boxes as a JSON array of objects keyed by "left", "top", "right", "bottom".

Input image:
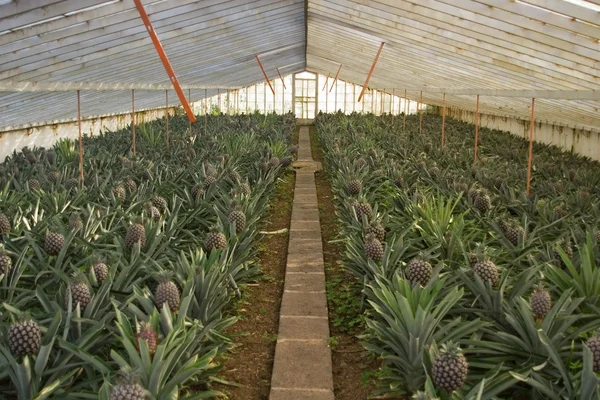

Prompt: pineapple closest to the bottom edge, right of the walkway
[{"left": 431, "top": 342, "right": 469, "bottom": 392}]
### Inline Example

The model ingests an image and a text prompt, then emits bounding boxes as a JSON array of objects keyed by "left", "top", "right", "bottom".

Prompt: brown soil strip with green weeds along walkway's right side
[{"left": 310, "top": 127, "right": 379, "bottom": 400}]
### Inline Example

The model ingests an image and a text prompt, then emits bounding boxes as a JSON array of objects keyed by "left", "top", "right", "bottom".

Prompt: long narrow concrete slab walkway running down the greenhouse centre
[{"left": 270, "top": 127, "right": 334, "bottom": 400}]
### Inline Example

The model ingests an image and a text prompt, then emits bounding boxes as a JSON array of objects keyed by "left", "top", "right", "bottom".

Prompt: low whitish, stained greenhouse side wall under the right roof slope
[{"left": 435, "top": 107, "right": 600, "bottom": 160}]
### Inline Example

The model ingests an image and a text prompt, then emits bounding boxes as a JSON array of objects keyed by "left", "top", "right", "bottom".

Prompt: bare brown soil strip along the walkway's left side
[{"left": 214, "top": 167, "right": 296, "bottom": 400}]
